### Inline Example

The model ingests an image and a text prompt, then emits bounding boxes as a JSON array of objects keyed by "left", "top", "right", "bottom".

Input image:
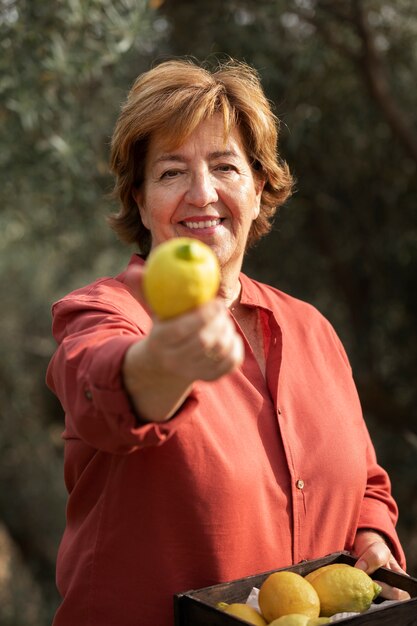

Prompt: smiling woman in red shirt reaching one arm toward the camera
[{"left": 47, "top": 61, "right": 405, "bottom": 626}]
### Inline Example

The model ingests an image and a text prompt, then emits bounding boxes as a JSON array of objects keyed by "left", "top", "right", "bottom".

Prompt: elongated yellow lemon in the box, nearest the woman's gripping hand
[{"left": 311, "top": 564, "right": 381, "bottom": 617}]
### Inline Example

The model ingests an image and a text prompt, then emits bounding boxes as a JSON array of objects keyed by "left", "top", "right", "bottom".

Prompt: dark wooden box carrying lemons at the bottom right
[{"left": 174, "top": 552, "right": 417, "bottom": 626}]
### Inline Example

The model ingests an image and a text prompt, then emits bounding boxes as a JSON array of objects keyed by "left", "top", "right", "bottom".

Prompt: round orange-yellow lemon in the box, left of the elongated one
[{"left": 258, "top": 571, "right": 320, "bottom": 622}]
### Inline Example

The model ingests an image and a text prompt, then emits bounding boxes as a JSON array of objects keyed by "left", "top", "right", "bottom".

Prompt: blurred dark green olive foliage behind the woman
[{"left": 0, "top": 0, "right": 417, "bottom": 626}]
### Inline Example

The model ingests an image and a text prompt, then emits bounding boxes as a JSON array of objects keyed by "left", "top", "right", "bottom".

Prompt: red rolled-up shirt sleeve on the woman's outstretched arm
[{"left": 46, "top": 285, "right": 195, "bottom": 454}]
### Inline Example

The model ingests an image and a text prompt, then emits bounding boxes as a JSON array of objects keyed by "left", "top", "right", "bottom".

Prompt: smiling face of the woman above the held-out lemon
[{"left": 135, "top": 115, "right": 263, "bottom": 269}]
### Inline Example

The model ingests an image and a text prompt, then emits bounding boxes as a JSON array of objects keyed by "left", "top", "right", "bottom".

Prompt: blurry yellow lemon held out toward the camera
[{"left": 143, "top": 237, "right": 220, "bottom": 319}]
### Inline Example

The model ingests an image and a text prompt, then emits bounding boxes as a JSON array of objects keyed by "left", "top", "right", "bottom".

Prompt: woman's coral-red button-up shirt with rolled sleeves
[{"left": 47, "top": 256, "right": 404, "bottom": 626}]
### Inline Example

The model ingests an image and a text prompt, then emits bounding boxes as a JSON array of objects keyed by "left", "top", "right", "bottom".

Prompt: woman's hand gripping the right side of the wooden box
[{"left": 353, "top": 529, "right": 410, "bottom": 600}]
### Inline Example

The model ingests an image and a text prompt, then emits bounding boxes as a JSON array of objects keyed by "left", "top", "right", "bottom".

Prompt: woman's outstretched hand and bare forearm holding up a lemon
[{"left": 122, "top": 260, "right": 244, "bottom": 421}]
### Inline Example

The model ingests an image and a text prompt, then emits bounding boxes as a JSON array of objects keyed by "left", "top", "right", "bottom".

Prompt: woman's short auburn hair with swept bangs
[{"left": 108, "top": 59, "right": 293, "bottom": 255}]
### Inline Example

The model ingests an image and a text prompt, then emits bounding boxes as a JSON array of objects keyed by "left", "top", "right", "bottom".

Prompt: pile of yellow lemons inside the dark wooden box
[{"left": 218, "top": 563, "right": 381, "bottom": 626}]
